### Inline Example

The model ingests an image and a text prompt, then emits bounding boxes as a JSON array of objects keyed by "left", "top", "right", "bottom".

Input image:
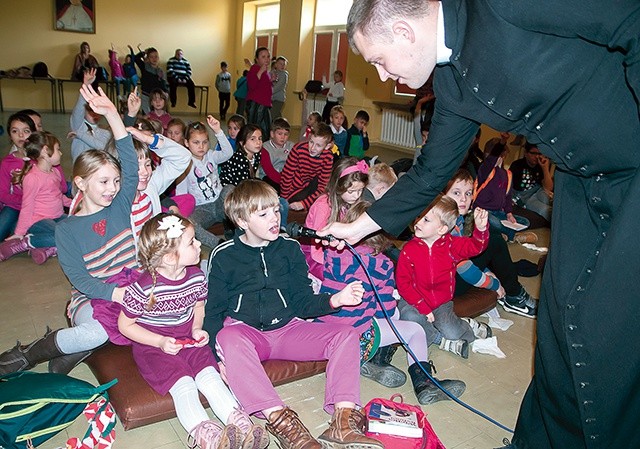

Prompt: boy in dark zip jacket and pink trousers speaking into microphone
[{"left": 204, "top": 179, "right": 384, "bottom": 449}]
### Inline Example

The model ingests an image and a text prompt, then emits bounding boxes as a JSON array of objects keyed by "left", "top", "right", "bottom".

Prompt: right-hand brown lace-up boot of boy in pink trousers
[{"left": 318, "top": 408, "right": 384, "bottom": 449}]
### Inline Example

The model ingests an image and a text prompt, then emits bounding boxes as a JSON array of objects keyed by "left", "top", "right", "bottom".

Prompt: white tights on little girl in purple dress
[{"left": 169, "top": 366, "right": 238, "bottom": 432}]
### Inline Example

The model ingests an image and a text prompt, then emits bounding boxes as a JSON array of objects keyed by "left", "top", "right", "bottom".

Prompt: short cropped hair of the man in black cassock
[{"left": 347, "top": 0, "right": 429, "bottom": 54}]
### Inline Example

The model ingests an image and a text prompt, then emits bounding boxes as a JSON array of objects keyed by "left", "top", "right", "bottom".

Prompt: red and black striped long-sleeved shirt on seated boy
[{"left": 280, "top": 142, "right": 333, "bottom": 209}]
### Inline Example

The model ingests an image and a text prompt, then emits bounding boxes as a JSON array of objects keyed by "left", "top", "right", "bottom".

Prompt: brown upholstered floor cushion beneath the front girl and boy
[{"left": 86, "top": 344, "right": 327, "bottom": 430}]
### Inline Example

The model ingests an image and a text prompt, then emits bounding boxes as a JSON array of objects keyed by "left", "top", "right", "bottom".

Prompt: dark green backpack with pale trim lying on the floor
[{"left": 0, "top": 371, "right": 118, "bottom": 449}]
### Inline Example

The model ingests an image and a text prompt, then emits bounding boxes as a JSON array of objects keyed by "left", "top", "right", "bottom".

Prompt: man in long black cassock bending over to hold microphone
[{"left": 320, "top": 0, "right": 640, "bottom": 449}]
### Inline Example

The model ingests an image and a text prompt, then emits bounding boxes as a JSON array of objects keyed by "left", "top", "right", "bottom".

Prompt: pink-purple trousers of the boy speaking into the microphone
[{"left": 216, "top": 318, "right": 360, "bottom": 414}]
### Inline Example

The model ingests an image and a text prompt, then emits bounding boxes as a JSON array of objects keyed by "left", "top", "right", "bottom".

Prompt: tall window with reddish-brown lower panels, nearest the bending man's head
[{"left": 311, "top": 0, "right": 353, "bottom": 85}]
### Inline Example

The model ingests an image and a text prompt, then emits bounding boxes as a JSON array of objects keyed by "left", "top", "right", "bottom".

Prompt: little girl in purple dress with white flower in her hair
[{"left": 118, "top": 213, "right": 269, "bottom": 449}]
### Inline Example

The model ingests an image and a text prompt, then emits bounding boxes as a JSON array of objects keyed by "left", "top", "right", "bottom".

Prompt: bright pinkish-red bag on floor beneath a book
[{"left": 364, "top": 394, "right": 446, "bottom": 449}]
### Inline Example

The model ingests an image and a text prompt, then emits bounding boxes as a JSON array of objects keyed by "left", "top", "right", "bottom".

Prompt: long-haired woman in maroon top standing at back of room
[{"left": 246, "top": 47, "right": 273, "bottom": 138}]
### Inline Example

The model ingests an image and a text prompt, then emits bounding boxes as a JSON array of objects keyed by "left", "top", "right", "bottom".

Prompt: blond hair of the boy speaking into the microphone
[{"left": 224, "top": 179, "right": 280, "bottom": 226}]
